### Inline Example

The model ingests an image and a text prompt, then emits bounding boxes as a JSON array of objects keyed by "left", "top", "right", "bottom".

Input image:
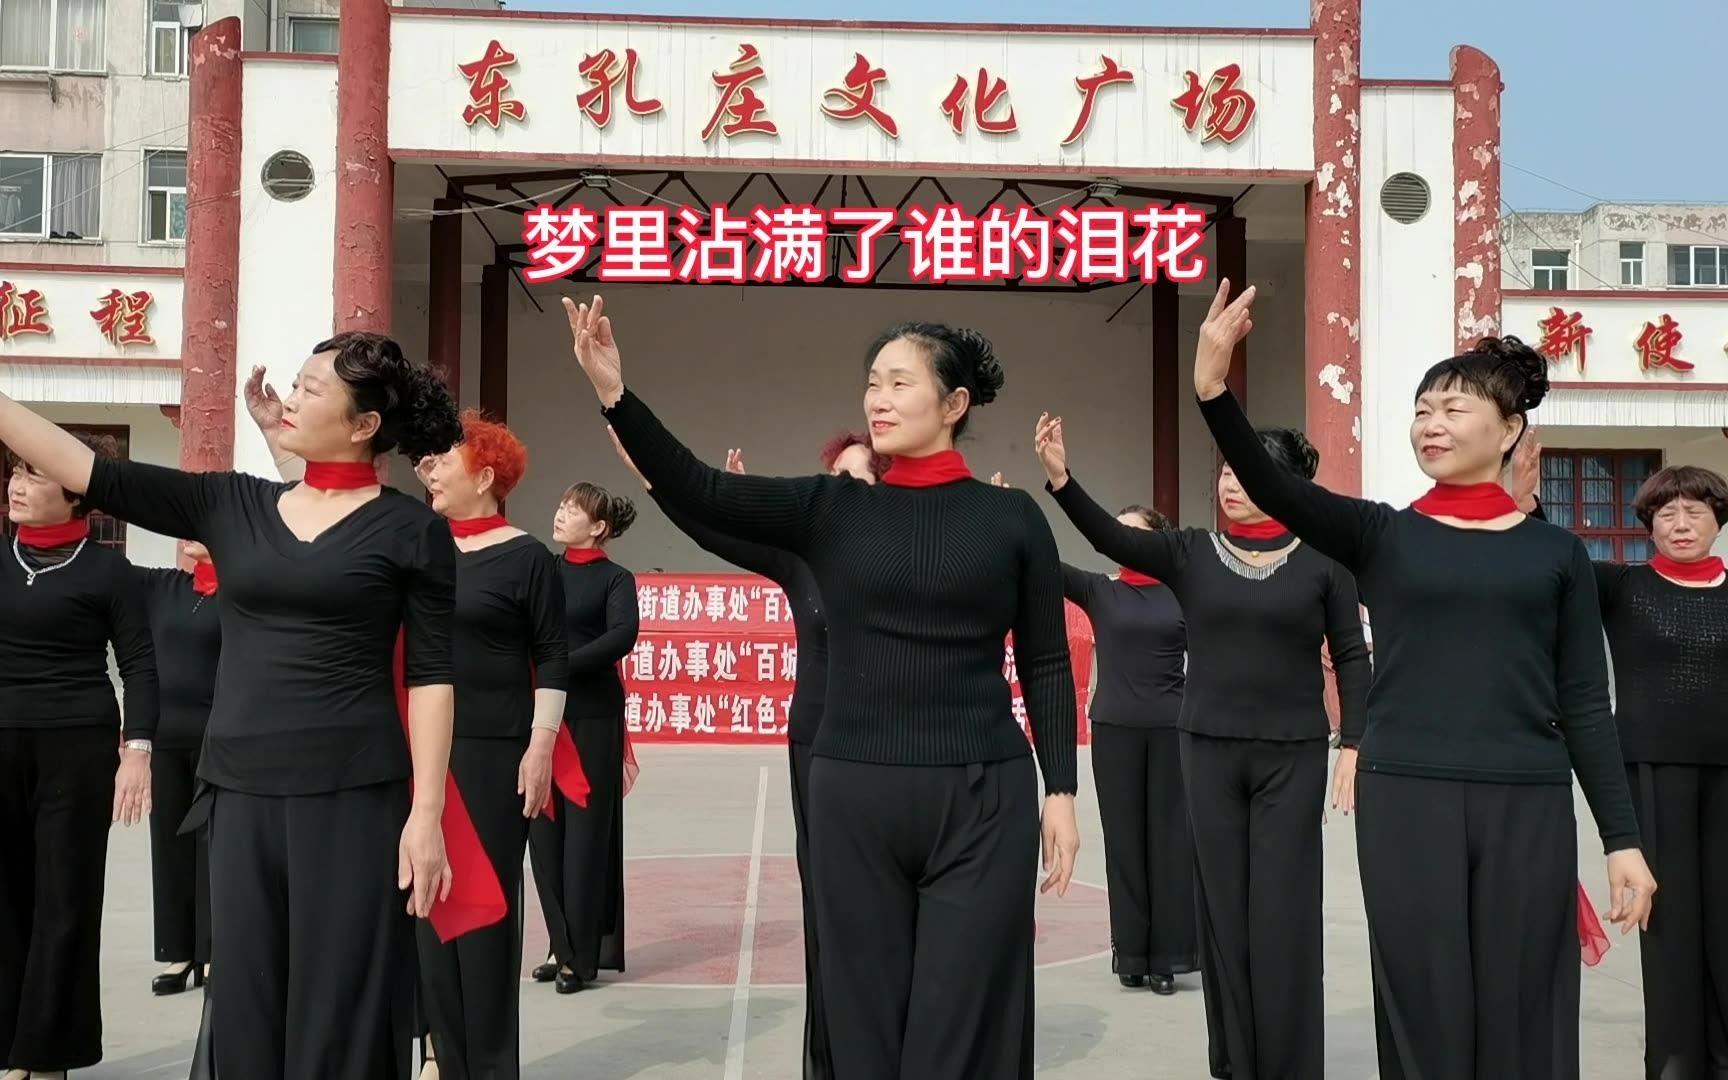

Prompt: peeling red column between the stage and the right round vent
[{"left": 1303, "top": 0, "right": 1362, "bottom": 494}]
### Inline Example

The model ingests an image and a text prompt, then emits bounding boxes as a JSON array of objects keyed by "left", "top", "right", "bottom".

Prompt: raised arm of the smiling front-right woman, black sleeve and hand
[{"left": 1194, "top": 282, "right": 1393, "bottom": 572}]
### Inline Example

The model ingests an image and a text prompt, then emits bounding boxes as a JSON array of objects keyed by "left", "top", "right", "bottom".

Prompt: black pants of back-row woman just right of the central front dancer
[{"left": 1092, "top": 724, "right": 1199, "bottom": 975}]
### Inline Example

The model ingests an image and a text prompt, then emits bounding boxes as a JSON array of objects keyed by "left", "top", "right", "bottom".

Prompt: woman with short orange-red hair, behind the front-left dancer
[{"left": 245, "top": 368, "right": 570, "bottom": 1080}]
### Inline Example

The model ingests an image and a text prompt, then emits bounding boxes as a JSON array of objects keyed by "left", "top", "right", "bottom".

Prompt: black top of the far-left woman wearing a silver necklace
[{"left": 0, "top": 539, "right": 161, "bottom": 745}]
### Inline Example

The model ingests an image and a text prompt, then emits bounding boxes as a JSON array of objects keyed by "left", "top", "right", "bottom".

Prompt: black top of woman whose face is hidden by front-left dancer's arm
[{"left": 133, "top": 567, "right": 221, "bottom": 750}]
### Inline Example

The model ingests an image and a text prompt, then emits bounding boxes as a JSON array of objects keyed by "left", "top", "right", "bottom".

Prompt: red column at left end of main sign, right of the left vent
[{"left": 335, "top": 0, "right": 396, "bottom": 334}]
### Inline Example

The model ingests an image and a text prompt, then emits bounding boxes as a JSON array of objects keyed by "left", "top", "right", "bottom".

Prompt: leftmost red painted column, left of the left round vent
[{"left": 180, "top": 17, "right": 242, "bottom": 472}]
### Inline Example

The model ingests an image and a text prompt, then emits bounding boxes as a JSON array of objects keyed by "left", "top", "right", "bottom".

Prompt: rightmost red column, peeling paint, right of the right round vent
[{"left": 1452, "top": 45, "right": 1505, "bottom": 353}]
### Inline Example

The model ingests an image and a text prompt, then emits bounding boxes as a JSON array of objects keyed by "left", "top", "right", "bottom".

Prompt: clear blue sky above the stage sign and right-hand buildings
[{"left": 528, "top": 0, "right": 1728, "bottom": 211}]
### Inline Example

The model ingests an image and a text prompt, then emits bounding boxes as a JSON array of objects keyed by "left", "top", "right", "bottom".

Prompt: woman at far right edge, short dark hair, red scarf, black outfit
[{"left": 1531, "top": 465, "right": 1728, "bottom": 1080}]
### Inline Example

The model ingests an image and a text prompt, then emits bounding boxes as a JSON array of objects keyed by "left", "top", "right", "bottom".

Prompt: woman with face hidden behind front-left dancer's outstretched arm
[{"left": 135, "top": 541, "right": 221, "bottom": 994}]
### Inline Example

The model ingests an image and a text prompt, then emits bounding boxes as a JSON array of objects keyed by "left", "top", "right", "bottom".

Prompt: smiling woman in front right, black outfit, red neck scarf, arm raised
[{"left": 1194, "top": 283, "right": 1655, "bottom": 1080}]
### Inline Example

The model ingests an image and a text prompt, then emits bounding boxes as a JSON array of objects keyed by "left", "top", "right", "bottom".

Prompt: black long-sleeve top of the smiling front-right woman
[{"left": 1199, "top": 391, "right": 1638, "bottom": 852}]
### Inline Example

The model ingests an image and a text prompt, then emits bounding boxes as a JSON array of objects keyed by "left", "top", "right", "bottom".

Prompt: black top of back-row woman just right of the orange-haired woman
[{"left": 560, "top": 558, "right": 641, "bottom": 719}]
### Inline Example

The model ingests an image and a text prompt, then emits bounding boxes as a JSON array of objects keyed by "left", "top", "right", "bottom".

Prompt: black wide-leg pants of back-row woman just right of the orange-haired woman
[{"left": 529, "top": 714, "right": 624, "bottom": 982}]
